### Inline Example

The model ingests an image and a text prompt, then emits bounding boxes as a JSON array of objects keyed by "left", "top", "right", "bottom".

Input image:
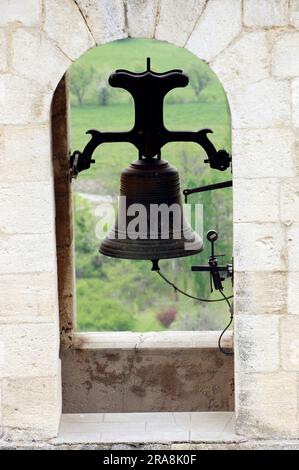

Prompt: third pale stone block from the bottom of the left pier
[{"left": 0, "top": 273, "right": 58, "bottom": 323}]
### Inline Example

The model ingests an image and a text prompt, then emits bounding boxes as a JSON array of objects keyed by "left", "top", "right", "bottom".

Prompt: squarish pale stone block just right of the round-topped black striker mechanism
[{"left": 234, "top": 222, "right": 286, "bottom": 272}]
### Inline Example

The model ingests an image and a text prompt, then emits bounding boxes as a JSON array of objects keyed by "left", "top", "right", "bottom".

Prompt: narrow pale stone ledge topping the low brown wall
[{"left": 73, "top": 331, "right": 233, "bottom": 349}]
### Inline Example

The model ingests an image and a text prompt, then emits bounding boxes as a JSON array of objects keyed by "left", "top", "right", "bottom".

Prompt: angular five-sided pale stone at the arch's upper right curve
[{"left": 211, "top": 31, "right": 270, "bottom": 92}]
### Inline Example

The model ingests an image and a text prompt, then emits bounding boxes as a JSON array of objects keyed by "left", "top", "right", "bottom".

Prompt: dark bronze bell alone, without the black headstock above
[{"left": 100, "top": 158, "right": 203, "bottom": 260}]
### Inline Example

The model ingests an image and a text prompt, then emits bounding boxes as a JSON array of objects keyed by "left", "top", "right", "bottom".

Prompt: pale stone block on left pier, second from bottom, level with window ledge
[{"left": 0, "top": 324, "right": 59, "bottom": 378}]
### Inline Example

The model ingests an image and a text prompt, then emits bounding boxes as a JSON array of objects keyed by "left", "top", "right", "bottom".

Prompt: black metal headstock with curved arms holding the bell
[{"left": 70, "top": 58, "right": 231, "bottom": 177}]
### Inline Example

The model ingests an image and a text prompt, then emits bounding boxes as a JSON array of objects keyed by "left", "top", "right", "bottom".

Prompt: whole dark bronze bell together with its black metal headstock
[{"left": 70, "top": 58, "right": 231, "bottom": 264}]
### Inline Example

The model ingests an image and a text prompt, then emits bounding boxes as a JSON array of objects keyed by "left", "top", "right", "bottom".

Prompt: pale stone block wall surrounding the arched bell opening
[{"left": 0, "top": 0, "right": 299, "bottom": 438}]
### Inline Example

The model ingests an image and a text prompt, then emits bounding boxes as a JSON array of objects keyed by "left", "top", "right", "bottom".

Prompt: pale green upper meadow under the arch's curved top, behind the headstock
[{"left": 70, "top": 39, "right": 221, "bottom": 106}]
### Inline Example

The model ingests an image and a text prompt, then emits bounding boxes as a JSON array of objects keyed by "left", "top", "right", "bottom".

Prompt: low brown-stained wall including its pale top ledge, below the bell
[{"left": 61, "top": 331, "right": 234, "bottom": 413}]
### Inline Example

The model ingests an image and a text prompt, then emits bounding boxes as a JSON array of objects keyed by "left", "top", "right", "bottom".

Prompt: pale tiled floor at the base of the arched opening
[{"left": 54, "top": 412, "right": 238, "bottom": 443}]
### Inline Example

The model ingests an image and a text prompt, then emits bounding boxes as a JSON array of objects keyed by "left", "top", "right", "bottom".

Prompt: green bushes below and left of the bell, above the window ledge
[{"left": 75, "top": 195, "right": 233, "bottom": 331}]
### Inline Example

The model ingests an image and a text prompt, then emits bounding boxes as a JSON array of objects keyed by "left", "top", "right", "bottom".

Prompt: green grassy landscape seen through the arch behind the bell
[{"left": 70, "top": 39, "right": 232, "bottom": 331}]
